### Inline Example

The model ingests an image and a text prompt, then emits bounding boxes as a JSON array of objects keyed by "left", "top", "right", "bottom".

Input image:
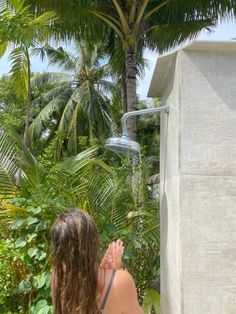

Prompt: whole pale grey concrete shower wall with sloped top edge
[{"left": 157, "top": 43, "right": 236, "bottom": 314}]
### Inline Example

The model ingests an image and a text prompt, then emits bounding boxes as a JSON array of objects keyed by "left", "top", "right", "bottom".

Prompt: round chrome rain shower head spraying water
[{"left": 105, "top": 134, "right": 140, "bottom": 153}]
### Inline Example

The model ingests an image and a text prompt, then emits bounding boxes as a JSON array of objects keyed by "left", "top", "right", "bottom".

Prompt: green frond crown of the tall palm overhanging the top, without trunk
[{"left": 27, "top": 0, "right": 235, "bottom": 51}]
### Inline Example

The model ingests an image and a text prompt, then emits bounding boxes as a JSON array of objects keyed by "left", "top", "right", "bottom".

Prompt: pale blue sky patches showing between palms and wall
[{"left": 0, "top": 21, "right": 236, "bottom": 99}]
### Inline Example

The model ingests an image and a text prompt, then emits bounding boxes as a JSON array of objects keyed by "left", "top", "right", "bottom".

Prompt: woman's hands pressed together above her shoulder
[{"left": 100, "top": 240, "right": 124, "bottom": 269}]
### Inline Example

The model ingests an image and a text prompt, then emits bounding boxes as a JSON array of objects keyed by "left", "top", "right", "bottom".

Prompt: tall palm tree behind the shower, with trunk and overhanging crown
[{"left": 26, "top": 0, "right": 235, "bottom": 138}]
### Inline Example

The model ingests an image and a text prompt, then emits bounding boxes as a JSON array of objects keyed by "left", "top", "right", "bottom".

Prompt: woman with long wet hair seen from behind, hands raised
[{"left": 51, "top": 208, "right": 143, "bottom": 314}]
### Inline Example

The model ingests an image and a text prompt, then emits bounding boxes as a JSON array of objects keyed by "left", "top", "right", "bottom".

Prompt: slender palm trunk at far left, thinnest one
[{"left": 23, "top": 48, "right": 31, "bottom": 146}]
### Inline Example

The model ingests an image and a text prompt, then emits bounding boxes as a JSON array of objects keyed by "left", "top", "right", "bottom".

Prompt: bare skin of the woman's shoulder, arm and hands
[{"left": 51, "top": 240, "right": 143, "bottom": 314}]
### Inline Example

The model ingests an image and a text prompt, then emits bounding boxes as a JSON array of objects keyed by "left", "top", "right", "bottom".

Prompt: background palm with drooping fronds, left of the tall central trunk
[{"left": 30, "top": 42, "right": 114, "bottom": 160}]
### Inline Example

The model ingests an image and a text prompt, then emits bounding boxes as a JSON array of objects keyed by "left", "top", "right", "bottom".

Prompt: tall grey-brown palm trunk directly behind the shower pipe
[{"left": 125, "top": 46, "right": 137, "bottom": 140}]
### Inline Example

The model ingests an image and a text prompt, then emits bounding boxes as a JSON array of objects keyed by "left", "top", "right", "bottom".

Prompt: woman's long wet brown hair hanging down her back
[{"left": 51, "top": 208, "right": 98, "bottom": 314}]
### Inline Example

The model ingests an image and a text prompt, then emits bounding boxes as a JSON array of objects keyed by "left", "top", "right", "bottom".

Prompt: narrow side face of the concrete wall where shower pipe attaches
[{"left": 160, "top": 52, "right": 181, "bottom": 314}]
